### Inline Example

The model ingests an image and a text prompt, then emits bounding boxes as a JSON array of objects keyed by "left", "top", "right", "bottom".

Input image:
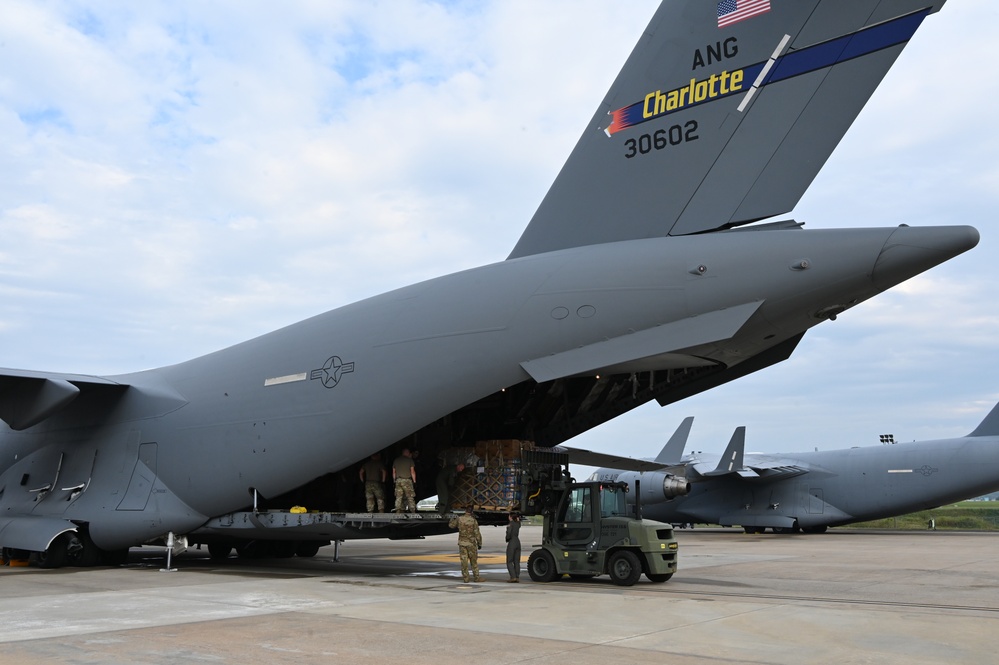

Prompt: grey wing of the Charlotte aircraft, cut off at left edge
[{"left": 0, "top": 368, "right": 128, "bottom": 430}]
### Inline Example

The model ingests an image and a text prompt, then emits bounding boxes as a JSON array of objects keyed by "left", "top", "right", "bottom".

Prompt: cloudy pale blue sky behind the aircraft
[{"left": 0, "top": 0, "right": 999, "bottom": 466}]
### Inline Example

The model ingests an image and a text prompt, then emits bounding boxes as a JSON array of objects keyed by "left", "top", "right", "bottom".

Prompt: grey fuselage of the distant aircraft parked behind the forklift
[{"left": 643, "top": 437, "right": 999, "bottom": 529}]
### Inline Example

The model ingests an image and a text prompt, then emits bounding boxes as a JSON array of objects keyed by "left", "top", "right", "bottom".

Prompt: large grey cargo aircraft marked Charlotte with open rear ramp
[{"left": 0, "top": 0, "right": 979, "bottom": 567}]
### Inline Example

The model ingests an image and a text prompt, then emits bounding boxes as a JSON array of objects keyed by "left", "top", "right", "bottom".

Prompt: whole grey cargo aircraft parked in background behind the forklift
[{"left": 584, "top": 404, "right": 999, "bottom": 534}]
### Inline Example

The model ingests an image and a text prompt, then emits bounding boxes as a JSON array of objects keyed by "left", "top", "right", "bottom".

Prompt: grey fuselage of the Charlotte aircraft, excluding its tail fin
[{"left": 0, "top": 227, "right": 977, "bottom": 548}]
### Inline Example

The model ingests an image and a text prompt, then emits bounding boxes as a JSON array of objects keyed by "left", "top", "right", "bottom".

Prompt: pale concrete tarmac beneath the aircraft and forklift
[{"left": 0, "top": 526, "right": 999, "bottom": 665}]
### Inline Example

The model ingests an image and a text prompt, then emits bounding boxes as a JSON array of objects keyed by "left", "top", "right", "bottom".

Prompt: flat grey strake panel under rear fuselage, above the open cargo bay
[{"left": 520, "top": 301, "right": 763, "bottom": 383}]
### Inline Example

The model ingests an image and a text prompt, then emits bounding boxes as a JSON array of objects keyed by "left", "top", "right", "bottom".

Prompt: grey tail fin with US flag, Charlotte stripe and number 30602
[{"left": 510, "top": 0, "right": 945, "bottom": 258}]
